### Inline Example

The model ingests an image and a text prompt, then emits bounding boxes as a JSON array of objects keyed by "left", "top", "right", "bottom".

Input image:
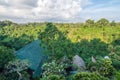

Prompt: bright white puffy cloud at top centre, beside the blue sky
[{"left": 33, "top": 0, "right": 82, "bottom": 19}]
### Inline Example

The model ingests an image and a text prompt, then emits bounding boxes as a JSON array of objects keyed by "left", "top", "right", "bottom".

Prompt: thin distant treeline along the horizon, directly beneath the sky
[{"left": 0, "top": 18, "right": 120, "bottom": 27}]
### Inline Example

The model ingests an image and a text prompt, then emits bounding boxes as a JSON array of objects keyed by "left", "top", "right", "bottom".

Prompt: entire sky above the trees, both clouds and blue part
[{"left": 0, "top": 0, "right": 120, "bottom": 23}]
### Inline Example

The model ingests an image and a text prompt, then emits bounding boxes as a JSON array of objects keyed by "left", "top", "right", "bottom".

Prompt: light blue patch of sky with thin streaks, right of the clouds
[{"left": 81, "top": 0, "right": 120, "bottom": 21}]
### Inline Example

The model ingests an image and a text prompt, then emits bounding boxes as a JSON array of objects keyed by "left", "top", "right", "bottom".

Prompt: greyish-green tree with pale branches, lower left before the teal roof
[{"left": 3, "top": 60, "right": 29, "bottom": 80}]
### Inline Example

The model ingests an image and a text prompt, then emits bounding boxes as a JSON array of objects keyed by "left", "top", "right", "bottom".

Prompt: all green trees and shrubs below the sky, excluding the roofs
[{"left": 0, "top": 18, "right": 120, "bottom": 80}]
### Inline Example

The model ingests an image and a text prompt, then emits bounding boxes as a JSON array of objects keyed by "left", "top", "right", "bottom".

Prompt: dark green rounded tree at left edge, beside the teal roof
[{"left": 0, "top": 46, "right": 15, "bottom": 68}]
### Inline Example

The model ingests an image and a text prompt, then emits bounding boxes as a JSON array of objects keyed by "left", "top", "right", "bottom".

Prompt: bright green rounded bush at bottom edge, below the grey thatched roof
[{"left": 73, "top": 72, "right": 109, "bottom": 80}]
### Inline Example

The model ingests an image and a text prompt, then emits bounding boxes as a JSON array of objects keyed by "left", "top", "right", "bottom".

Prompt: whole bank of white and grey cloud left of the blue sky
[{"left": 0, "top": 0, "right": 89, "bottom": 21}]
